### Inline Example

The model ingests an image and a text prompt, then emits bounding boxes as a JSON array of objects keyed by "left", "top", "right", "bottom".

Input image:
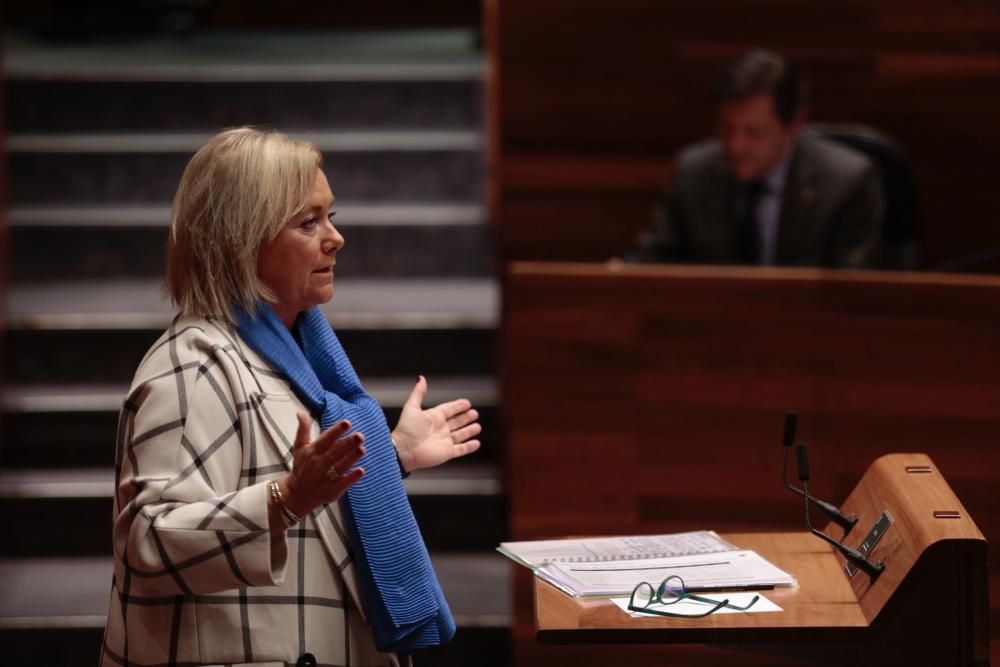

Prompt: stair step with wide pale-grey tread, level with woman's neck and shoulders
[{"left": 3, "top": 277, "right": 499, "bottom": 385}]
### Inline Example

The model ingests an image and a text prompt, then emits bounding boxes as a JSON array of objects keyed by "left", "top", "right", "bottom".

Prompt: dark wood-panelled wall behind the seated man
[{"left": 484, "top": 0, "right": 1000, "bottom": 270}]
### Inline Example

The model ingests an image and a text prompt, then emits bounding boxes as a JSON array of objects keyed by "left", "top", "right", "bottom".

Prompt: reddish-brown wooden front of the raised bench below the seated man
[{"left": 502, "top": 264, "right": 1000, "bottom": 660}]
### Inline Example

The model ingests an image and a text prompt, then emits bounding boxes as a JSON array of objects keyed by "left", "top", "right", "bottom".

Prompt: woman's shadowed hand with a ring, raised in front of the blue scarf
[{"left": 278, "top": 411, "right": 365, "bottom": 517}]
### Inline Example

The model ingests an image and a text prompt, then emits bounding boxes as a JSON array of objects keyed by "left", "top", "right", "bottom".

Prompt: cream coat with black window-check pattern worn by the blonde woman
[{"left": 101, "top": 318, "right": 400, "bottom": 667}]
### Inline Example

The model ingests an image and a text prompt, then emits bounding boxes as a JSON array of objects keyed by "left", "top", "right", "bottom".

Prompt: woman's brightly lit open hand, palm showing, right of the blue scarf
[{"left": 392, "top": 375, "right": 483, "bottom": 472}]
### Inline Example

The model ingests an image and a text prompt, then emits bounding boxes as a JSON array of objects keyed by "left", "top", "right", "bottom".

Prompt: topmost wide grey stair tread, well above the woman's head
[{"left": 3, "top": 29, "right": 484, "bottom": 82}]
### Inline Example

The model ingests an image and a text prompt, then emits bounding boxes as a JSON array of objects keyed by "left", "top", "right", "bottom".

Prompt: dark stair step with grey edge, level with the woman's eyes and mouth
[{"left": 8, "top": 200, "right": 493, "bottom": 283}]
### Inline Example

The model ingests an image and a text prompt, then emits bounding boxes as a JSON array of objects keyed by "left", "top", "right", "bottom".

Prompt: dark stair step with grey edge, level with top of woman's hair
[{"left": 6, "top": 136, "right": 485, "bottom": 205}]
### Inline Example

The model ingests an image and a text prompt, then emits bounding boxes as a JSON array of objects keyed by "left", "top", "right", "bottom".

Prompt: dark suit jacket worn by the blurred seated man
[{"left": 626, "top": 132, "right": 884, "bottom": 267}]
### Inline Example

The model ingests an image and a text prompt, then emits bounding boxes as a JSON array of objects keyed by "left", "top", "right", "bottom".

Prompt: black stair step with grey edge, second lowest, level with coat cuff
[{"left": 0, "top": 462, "right": 507, "bottom": 558}]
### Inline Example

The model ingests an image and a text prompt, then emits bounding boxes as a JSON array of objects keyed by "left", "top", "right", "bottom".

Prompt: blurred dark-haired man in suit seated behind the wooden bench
[{"left": 625, "top": 49, "right": 884, "bottom": 267}]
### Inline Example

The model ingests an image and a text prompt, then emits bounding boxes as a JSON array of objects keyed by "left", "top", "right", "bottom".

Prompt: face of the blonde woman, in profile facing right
[{"left": 257, "top": 169, "right": 344, "bottom": 328}]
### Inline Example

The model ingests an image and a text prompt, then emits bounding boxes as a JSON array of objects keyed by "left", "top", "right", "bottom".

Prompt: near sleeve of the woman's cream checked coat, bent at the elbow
[{"left": 114, "top": 337, "right": 287, "bottom": 595}]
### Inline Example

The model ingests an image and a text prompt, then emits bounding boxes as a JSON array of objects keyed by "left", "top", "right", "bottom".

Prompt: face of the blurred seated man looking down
[{"left": 719, "top": 94, "right": 802, "bottom": 183}]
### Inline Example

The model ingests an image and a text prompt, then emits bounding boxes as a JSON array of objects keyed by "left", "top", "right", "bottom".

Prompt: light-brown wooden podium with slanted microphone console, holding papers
[{"left": 535, "top": 454, "right": 989, "bottom": 666}]
